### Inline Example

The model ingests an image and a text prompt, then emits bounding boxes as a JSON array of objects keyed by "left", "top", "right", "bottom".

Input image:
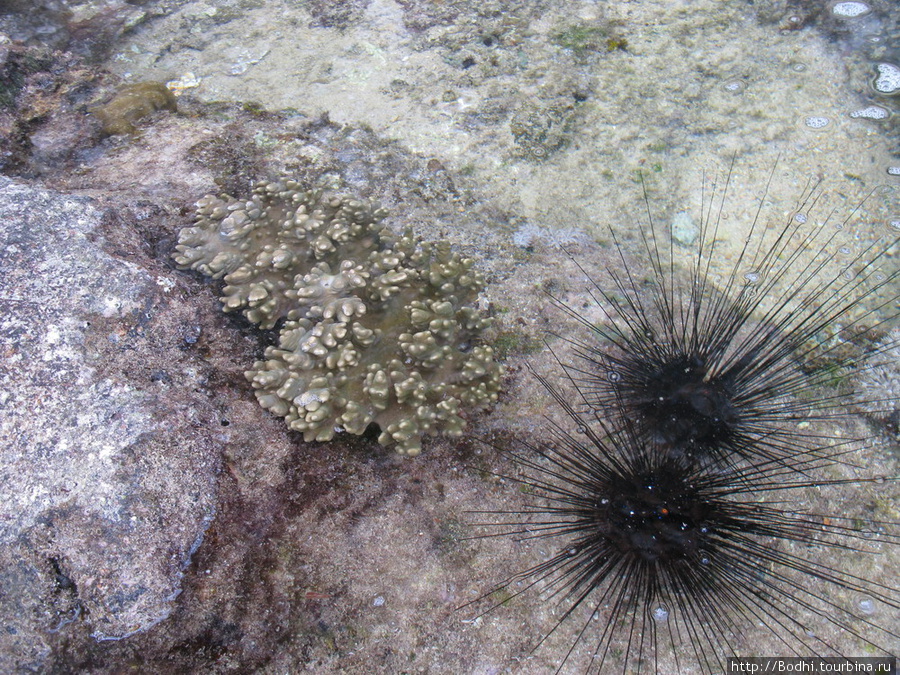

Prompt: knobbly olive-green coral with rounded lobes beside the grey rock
[{"left": 174, "top": 180, "right": 501, "bottom": 455}]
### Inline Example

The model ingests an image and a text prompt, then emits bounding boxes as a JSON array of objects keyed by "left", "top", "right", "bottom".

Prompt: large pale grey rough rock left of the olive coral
[{"left": 0, "top": 178, "right": 218, "bottom": 672}]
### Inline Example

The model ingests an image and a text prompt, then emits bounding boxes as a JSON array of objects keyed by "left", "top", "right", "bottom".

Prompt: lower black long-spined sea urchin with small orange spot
[{"left": 468, "top": 382, "right": 900, "bottom": 673}]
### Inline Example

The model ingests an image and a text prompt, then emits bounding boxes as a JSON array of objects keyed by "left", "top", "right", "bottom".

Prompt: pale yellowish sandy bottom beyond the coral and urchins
[{"left": 110, "top": 0, "right": 900, "bottom": 243}]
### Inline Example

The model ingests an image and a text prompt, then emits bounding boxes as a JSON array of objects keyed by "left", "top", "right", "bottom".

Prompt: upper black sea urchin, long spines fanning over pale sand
[{"left": 563, "top": 164, "right": 900, "bottom": 470}]
